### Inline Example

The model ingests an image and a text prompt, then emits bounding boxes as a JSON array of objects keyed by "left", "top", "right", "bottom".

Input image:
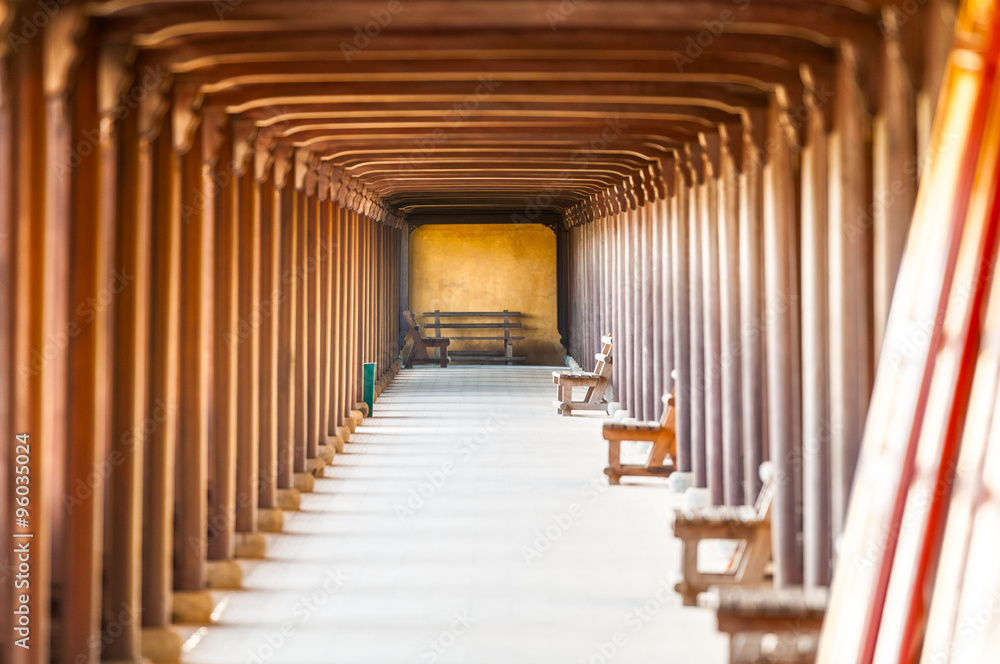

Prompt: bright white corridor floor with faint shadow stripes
[{"left": 184, "top": 366, "right": 727, "bottom": 664}]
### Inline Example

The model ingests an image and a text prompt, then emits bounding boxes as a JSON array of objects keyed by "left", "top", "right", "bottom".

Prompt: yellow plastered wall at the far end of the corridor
[{"left": 410, "top": 224, "right": 564, "bottom": 365}]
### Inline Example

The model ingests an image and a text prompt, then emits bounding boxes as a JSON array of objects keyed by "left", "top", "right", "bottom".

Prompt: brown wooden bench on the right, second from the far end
[{"left": 604, "top": 394, "right": 677, "bottom": 484}]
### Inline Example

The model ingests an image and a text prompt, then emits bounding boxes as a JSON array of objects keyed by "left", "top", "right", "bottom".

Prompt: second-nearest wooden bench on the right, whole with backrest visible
[{"left": 674, "top": 463, "right": 776, "bottom": 606}]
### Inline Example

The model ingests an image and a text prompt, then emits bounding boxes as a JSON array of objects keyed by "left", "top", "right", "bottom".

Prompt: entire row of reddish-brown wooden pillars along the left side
[{"left": 0, "top": 23, "right": 402, "bottom": 664}]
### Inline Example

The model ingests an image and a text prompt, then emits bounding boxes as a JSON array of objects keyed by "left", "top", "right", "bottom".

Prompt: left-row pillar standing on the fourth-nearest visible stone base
[{"left": 233, "top": 145, "right": 263, "bottom": 533}]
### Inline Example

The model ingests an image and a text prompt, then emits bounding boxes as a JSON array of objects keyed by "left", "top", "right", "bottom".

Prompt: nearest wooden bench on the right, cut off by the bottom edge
[{"left": 706, "top": 586, "right": 830, "bottom": 664}]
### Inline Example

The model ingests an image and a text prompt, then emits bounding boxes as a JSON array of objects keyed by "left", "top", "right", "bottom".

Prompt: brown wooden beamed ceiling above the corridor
[{"left": 50, "top": 0, "right": 919, "bottom": 219}]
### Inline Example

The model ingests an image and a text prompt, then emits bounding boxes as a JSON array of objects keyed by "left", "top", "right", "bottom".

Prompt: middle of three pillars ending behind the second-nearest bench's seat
[{"left": 716, "top": 127, "right": 744, "bottom": 505}]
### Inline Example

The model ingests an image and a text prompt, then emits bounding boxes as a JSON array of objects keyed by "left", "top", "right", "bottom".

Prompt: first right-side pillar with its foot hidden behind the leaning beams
[{"left": 829, "top": 46, "right": 874, "bottom": 533}]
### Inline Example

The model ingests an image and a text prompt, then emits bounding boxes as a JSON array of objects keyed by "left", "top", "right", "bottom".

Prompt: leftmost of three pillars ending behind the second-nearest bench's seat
[{"left": 698, "top": 139, "right": 726, "bottom": 505}]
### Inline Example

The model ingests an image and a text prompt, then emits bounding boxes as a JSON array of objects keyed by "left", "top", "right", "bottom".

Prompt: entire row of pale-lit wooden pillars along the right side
[{"left": 560, "top": 13, "right": 951, "bottom": 586}]
